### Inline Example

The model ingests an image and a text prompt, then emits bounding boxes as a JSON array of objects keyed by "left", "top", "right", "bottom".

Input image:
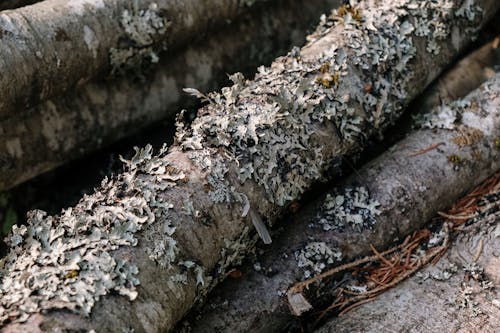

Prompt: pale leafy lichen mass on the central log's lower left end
[{"left": 0, "top": 146, "right": 184, "bottom": 323}]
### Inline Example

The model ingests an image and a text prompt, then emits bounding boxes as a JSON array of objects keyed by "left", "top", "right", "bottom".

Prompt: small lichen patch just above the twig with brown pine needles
[{"left": 295, "top": 242, "right": 342, "bottom": 279}]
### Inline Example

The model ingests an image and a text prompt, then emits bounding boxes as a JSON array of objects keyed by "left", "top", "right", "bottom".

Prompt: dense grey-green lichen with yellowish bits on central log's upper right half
[{"left": 180, "top": 0, "right": 475, "bottom": 206}]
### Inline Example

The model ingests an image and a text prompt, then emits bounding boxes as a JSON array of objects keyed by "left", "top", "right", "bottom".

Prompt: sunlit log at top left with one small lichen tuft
[{"left": 0, "top": 0, "right": 272, "bottom": 119}]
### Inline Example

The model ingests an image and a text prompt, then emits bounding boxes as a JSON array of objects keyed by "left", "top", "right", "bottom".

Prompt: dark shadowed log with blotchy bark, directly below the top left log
[{"left": 0, "top": 0, "right": 339, "bottom": 190}]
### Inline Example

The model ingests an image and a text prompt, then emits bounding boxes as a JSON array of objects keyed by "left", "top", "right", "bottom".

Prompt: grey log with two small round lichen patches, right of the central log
[{"left": 179, "top": 74, "right": 500, "bottom": 332}]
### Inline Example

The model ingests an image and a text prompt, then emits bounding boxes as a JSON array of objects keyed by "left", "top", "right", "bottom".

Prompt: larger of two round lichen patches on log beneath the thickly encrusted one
[{"left": 316, "top": 187, "right": 380, "bottom": 231}]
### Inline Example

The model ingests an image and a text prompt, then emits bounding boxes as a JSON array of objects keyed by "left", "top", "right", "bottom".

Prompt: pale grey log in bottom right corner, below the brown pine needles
[{"left": 318, "top": 201, "right": 500, "bottom": 333}]
